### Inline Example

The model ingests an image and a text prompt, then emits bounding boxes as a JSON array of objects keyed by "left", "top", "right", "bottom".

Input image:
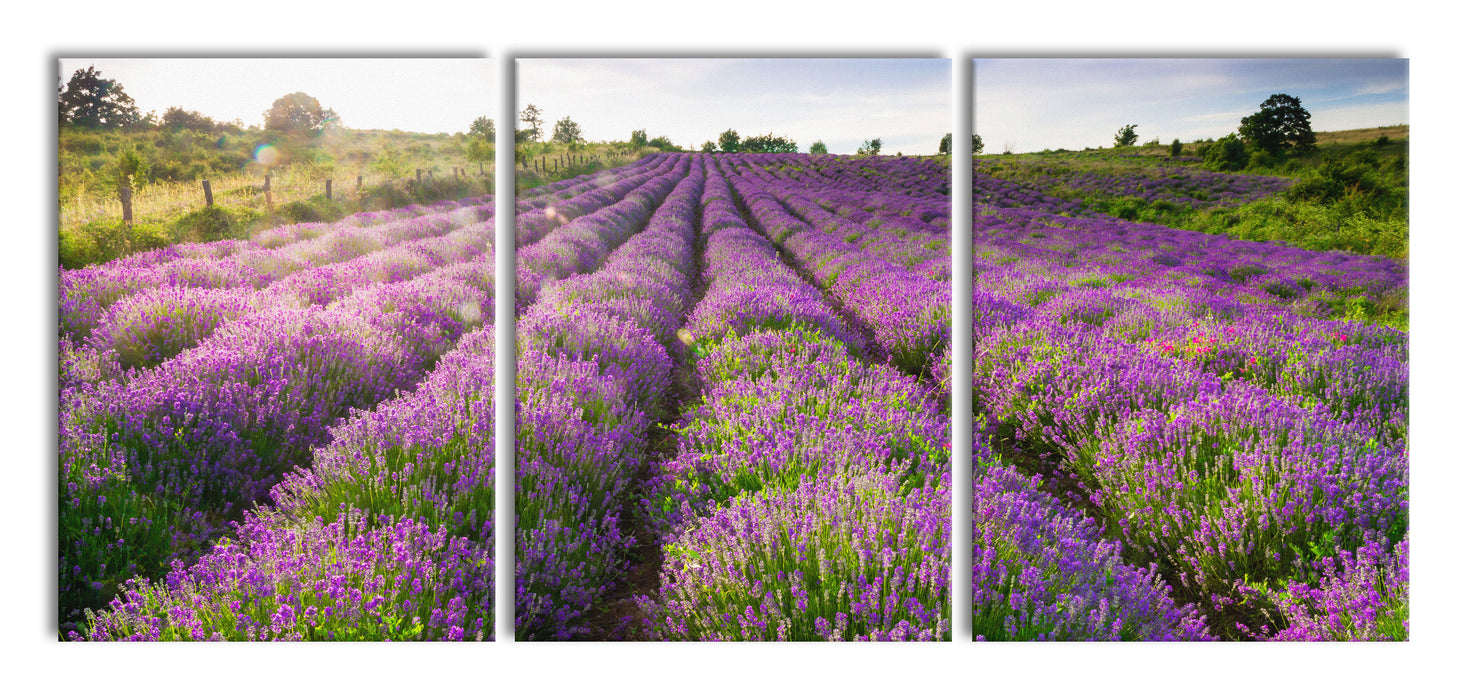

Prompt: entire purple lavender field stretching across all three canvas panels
[{"left": 57, "top": 153, "right": 1409, "bottom": 640}]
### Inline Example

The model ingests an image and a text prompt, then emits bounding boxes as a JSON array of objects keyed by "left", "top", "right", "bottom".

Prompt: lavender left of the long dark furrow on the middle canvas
[{"left": 515, "top": 154, "right": 702, "bottom": 640}]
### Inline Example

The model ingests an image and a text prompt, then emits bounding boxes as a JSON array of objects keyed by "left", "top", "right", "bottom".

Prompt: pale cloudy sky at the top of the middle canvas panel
[{"left": 515, "top": 59, "right": 953, "bottom": 156}]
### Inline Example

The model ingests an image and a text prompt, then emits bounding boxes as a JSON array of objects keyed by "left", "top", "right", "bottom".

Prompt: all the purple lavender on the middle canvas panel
[{"left": 515, "top": 154, "right": 951, "bottom": 640}]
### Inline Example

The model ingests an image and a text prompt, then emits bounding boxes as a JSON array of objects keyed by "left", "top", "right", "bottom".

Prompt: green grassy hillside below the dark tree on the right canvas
[{"left": 975, "top": 125, "right": 1408, "bottom": 260}]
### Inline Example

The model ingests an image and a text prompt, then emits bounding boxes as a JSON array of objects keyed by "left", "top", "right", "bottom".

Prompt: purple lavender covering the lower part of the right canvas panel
[{"left": 973, "top": 198, "right": 1408, "bottom": 638}]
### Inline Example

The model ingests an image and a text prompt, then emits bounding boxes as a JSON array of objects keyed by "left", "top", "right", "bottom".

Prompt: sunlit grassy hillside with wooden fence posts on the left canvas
[{"left": 57, "top": 125, "right": 493, "bottom": 267}]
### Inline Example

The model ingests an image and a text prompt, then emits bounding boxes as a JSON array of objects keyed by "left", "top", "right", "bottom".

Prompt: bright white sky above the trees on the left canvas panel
[{"left": 59, "top": 57, "right": 499, "bottom": 134}]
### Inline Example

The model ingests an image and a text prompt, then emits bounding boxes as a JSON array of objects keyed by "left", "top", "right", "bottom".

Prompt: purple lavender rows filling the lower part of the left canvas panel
[{"left": 59, "top": 193, "right": 495, "bottom": 638}]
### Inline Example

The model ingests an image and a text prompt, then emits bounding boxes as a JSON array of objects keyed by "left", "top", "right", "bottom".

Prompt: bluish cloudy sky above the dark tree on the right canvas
[{"left": 973, "top": 59, "right": 1408, "bottom": 153}]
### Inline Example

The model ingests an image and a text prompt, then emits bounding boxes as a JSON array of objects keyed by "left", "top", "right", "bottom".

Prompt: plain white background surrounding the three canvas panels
[{"left": 0, "top": 0, "right": 1468, "bottom": 699}]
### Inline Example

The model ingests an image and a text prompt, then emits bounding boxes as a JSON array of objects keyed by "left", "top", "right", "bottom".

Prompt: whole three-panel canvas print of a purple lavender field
[{"left": 57, "top": 57, "right": 1409, "bottom": 643}]
